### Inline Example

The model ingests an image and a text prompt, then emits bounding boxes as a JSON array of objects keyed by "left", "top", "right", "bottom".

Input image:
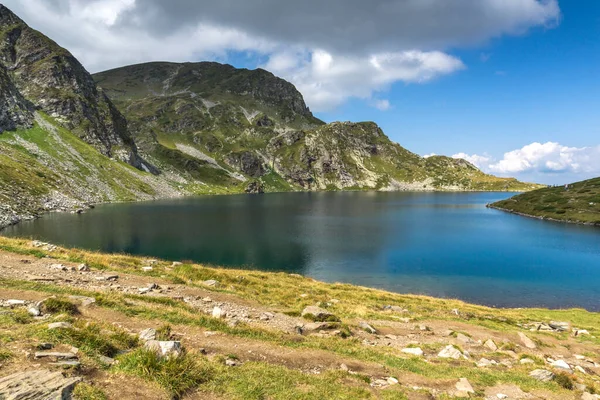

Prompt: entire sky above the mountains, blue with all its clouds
[{"left": 0, "top": 0, "right": 600, "bottom": 184}]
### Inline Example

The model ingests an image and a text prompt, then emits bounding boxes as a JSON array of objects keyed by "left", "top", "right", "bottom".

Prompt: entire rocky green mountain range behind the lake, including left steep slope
[{"left": 0, "top": 5, "right": 534, "bottom": 229}]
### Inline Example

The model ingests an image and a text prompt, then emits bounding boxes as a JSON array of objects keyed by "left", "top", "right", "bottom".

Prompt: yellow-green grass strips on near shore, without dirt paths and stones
[{"left": 0, "top": 238, "right": 600, "bottom": 399}]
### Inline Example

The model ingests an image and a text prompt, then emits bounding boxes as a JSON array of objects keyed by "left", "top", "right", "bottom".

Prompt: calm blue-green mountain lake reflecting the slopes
[{"left": 2, "top": 192, "right": 600, "bottom": 311}]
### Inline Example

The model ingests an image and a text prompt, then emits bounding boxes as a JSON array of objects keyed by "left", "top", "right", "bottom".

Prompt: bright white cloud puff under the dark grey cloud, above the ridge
[{"left": 264, "top": 50, "right": 465, "bottom": 111}]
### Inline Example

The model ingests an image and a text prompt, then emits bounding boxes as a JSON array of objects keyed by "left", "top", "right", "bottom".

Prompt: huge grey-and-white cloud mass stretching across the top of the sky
[{"left": 4, "top": 0, "right": 560, "bottom": 111}]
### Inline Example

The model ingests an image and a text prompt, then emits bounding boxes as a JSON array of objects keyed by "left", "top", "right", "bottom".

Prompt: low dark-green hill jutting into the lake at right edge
[{"left": 490, "top": 178, "right": 600, "bottom": 225}]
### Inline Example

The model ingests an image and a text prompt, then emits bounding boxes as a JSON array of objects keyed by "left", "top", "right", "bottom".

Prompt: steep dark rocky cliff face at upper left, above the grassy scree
[{"left": 0, "top": 5, "right": 142, "bottom": 168}]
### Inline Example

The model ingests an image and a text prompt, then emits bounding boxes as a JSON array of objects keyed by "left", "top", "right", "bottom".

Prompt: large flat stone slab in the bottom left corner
[{"left": 0, "top": 370, "right": 81, "bottom": 400}]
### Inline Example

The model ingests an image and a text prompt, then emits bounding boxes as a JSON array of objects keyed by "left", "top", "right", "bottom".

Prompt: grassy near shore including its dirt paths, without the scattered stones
[{"left": 0, "top": 237, "right": 600, "bottom": 399}]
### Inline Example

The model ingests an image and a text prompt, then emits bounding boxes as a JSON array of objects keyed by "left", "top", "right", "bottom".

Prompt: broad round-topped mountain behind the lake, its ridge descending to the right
[{"left": 94, "top": 62, "right": 535, "bottom": 191}]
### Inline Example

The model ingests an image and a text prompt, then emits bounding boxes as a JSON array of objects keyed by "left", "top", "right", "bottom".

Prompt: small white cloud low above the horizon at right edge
[{"left": 489, "top": 142, "right": 600, "bottom": 174}]
